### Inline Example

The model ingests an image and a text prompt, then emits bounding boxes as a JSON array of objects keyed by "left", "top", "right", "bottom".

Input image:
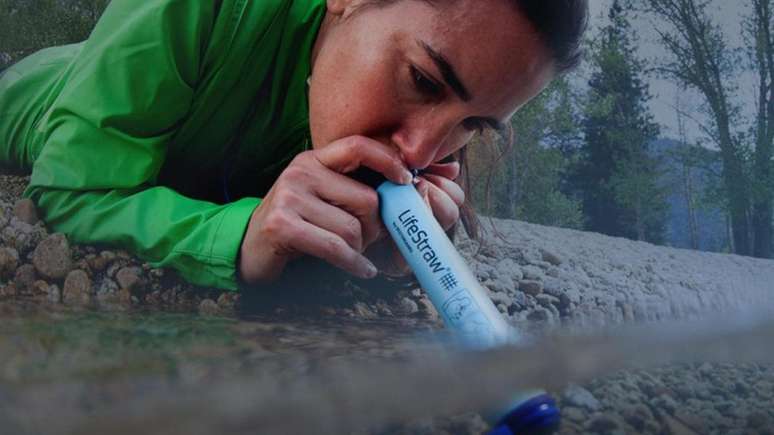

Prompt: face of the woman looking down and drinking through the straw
[{"left": 309, "top": 0, "right": 552, "bottom": 169}]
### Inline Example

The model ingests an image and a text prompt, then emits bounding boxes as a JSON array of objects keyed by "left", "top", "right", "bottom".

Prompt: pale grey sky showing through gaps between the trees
[{"left": 580, "top": 0, "right": 755, "bottom": 148}]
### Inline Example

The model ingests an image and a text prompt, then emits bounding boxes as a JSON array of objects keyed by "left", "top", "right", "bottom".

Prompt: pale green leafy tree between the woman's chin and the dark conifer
[{"left": 471, "top": 78, "right": 582, "bottom": 232}]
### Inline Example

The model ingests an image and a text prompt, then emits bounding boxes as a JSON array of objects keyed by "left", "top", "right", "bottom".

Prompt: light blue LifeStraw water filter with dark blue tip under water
[{"left": 377, "top": 181, "right": 560, "bottom": 435}]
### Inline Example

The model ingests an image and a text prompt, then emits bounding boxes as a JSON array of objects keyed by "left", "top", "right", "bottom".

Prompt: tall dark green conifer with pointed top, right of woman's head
[{"left": 574, "top": 0, "right": 667, "bottom": 243}]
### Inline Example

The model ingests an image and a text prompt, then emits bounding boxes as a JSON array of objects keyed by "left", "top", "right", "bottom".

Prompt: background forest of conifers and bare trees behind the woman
[{"left": 0, "top": 0, "right": 774, "bottom": 258}]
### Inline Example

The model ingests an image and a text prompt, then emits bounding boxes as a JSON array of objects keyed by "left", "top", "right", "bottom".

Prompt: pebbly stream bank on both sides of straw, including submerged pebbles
[{"left": 0, "top": 176, "right": 774, "bottom": 434}]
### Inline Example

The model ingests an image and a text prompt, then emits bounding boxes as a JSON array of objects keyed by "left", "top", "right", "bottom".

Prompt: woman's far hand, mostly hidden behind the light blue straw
[{"left": 366, "top": 162, "right": 465, "bottom": 277}]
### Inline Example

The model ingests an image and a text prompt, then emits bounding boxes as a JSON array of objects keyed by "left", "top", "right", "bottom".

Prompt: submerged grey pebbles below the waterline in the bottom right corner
[{"left": 559, "top": 363, "right": 774, "bottom": 435}]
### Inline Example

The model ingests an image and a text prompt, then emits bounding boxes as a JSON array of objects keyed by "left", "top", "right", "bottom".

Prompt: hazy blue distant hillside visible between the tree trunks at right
[{"left": 651, "top": 139, "right": 728, "bottom": 252}]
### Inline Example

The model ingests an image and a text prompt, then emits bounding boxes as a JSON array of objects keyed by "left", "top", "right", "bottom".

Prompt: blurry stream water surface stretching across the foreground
[{"left": 0, "top": 304, "right": 774, "bottom": 434}]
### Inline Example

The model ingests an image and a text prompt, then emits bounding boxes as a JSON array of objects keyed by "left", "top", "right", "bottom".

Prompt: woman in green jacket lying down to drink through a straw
[{"left": 0, "top": 0, "right": 587, "bottom": 289}]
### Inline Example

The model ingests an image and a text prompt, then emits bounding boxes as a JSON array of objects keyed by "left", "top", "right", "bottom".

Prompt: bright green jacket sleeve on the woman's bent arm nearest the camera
[{"left": 24, "top": 0, "right": 260, "bottom": 290}]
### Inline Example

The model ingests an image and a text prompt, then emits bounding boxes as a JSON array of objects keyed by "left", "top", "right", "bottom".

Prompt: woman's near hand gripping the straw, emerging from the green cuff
[{"left": 238, "top": 136, "right": 416, "bottom": 284}]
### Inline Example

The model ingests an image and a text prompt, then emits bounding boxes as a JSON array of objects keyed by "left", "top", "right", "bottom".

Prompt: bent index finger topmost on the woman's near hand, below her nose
[{"left": 313, "top": 136, "right": 413, "bottom": 184}]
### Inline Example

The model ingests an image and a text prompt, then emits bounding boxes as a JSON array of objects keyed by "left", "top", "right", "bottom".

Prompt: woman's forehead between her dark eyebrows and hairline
[{"left": 405, "top": 0, "right": 553, "bottom": 115}]
